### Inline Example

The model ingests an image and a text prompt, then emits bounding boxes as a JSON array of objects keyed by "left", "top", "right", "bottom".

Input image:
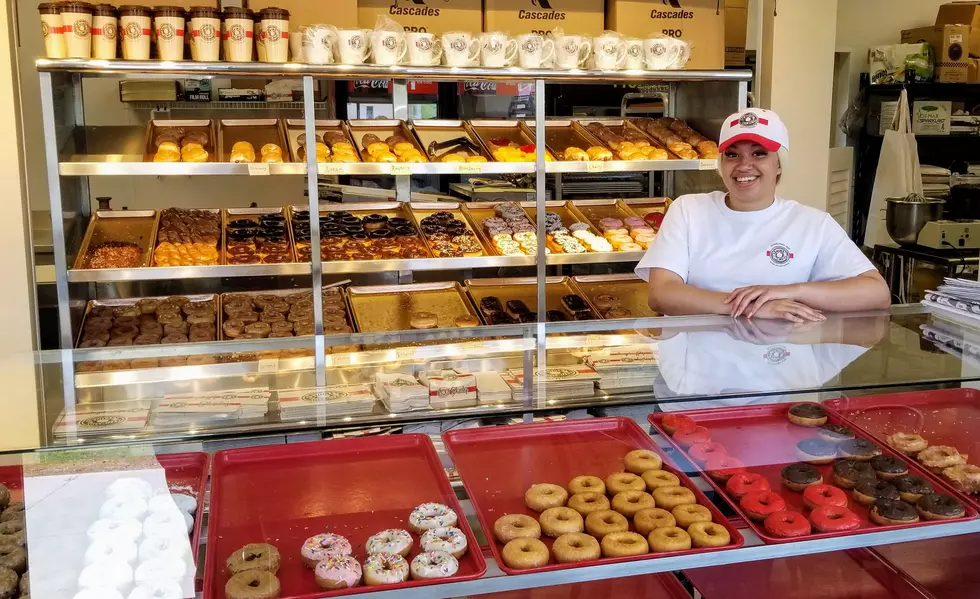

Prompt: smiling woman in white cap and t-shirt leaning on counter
[{"left": 636, "top": 108, "right": 891, "bottom": 322}]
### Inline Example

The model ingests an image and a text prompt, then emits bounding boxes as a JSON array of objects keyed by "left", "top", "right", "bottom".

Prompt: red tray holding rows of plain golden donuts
[{"left": 442, "top": 418, "right": 745, "bottom": 574}]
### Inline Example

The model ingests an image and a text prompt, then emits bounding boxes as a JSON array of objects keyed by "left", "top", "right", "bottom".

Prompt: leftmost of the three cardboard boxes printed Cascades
[{"left": 357, "top": 0, "right": 483, "bottom": 35}]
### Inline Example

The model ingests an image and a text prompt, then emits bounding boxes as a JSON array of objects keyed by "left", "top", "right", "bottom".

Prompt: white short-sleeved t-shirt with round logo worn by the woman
[{"left": 636, "top": 191, "right": 875, "bottom": 293}]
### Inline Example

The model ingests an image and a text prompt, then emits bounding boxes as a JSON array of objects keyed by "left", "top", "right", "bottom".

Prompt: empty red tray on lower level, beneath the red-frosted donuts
[{"left": 684, "top": 549, "right": 928, "bottom": 599}]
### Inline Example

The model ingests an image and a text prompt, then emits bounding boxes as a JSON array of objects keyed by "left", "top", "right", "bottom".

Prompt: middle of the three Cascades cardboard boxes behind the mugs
[{"left": 483, "top": 0, "right": 605, "bottom": 36}]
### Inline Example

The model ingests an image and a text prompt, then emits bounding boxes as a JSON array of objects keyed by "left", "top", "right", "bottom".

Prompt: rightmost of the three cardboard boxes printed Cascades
[{"left": 608, "top": 0, "right": 725, "bottom": 69}]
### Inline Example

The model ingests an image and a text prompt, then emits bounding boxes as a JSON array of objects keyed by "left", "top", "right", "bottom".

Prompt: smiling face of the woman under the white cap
[{"left": 721, "top": 141, "right": 780, "bottom": 204}]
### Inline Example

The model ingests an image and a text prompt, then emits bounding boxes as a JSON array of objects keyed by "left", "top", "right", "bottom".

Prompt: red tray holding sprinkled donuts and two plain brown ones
[{"left": 204, "top": 435, "right": 487, "bottom": 599}]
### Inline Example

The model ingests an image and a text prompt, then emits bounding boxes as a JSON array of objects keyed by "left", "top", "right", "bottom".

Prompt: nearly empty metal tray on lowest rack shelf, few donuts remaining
[{"left": 347, "top": 282, "right": 479, "bottom": 333}]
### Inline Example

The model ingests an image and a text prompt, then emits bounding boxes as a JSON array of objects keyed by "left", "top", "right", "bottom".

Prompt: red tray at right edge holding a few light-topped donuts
[{"left": 823, "top": 389, "right": 980, "bottom": 510}]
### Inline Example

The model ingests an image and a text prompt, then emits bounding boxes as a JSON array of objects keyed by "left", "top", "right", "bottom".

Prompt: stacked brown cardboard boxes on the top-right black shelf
[{"left": 902, "top": 1, "right": 980, "bottom": 83}]
